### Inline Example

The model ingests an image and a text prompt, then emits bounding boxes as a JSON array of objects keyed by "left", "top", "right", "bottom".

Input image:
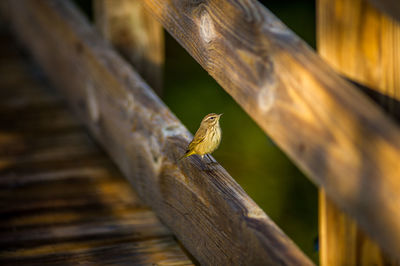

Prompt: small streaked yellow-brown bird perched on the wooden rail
[{"left": 179, "top": 113, "right": 222, "bottom": 160}]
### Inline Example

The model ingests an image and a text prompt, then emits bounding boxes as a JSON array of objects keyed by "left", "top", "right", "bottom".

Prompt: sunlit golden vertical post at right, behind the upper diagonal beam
[{"left": 317, "top": 0, "right": 400, "bottom": 266}]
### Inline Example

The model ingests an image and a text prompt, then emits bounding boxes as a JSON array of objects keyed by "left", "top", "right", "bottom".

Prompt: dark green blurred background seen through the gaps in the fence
[{"left": 76, "top": 0, "right": 318, "bottom": 263}]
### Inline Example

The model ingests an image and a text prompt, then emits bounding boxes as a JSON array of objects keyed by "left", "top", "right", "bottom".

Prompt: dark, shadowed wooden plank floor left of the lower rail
[{"left": 0, "top": 28, "right": 193, "bottom": 265}]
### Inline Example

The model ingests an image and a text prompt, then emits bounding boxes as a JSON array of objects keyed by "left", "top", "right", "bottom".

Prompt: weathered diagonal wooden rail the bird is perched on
[{"left": 0, "top": 0, "right": 312, "bottom": 265}]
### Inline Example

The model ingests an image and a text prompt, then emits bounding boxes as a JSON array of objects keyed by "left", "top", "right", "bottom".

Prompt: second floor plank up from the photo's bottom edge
[{"left": 0, "top": 212, "right": 171, "bottom": 247}]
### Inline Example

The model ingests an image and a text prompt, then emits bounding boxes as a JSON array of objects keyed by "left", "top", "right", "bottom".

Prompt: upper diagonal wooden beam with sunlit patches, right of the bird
[{"left": 143, "top": 0, "right": 400, "bottom": 257}]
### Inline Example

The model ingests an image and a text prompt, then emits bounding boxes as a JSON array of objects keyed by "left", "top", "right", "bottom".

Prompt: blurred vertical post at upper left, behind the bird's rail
[{"left": 94, "top": 0, "right": 164, "bottom": 95}]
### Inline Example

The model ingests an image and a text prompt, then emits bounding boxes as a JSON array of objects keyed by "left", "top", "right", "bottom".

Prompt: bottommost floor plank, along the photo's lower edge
[{"left": 0, "top": 238, "right": 193, "bottom": 265}]
